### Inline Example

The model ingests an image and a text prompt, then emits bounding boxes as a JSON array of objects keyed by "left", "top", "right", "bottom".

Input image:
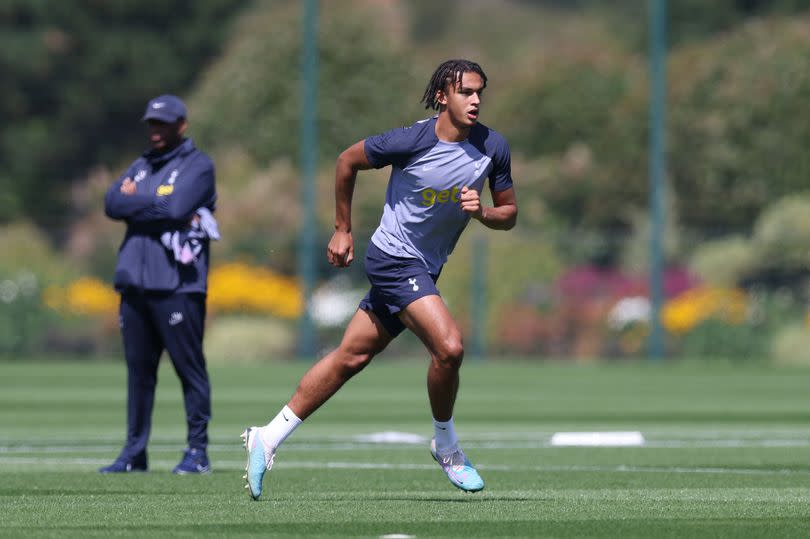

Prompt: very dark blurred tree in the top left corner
[{"left": 0, "top": 0, "right": 246, "bottom": 230}]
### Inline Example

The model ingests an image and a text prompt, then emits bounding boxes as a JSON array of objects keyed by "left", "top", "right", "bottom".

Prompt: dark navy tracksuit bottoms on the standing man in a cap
[{"left": 120, "top": 292, "right": 211, "bottom": 457}]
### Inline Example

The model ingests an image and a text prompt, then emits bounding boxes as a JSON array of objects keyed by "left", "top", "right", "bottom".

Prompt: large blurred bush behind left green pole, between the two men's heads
[{"left": 191, "top": 2, "right": 416, "bottom": 169}]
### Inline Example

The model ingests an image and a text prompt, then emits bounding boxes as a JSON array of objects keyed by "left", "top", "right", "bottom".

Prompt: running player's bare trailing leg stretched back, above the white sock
[{"left": 287, "top": 309, "right": 391, "bottom": 420}]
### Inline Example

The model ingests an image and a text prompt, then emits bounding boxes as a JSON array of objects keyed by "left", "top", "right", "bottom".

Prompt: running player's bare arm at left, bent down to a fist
[{"left": 326, "top": 140, "right": 372, "bottom": 268}]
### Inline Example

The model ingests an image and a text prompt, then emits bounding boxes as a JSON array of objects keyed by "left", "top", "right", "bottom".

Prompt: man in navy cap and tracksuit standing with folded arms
[{"left": 99, "top": 95, "right": 219, "bottom": 474}]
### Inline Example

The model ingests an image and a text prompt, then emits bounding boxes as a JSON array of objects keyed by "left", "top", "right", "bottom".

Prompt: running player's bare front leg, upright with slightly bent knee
[{"left": 399, "top": 296, "right": 464, "bottom": 421}]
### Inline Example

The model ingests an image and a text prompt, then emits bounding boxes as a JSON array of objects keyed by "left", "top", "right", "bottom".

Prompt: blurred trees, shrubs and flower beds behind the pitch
[{"left": 0, "top": 0, "right": 810, "bottom": 357}]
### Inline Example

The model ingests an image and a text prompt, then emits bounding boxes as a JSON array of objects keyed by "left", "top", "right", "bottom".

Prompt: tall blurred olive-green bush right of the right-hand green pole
[{"left": 669, "top": 16, "right": 810, "bottom": 231}]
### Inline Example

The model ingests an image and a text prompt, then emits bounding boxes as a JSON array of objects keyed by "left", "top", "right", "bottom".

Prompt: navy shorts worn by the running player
[{"left": 360, "top": 241, "right": 440, "bottom": 337}]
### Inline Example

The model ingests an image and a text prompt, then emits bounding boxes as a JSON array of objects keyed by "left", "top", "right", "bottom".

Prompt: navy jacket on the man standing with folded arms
[{"left": 104, "top": 138, "right": 217, "bottom": 293}]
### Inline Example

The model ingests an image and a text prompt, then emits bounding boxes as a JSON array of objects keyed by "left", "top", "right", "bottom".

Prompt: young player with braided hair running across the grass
[{"left": 242, "top": 60, "right": 517, "bottom": 500}]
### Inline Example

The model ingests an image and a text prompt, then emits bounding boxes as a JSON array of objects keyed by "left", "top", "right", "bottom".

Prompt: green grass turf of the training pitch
[{"left": 0, "top": 358, "right": 810, "bottom": 539}]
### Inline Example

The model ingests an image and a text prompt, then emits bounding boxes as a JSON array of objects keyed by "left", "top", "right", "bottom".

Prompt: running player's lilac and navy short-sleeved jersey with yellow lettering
[{"left": 365, "top": 116, "right": 512, "bottom": 275}]
